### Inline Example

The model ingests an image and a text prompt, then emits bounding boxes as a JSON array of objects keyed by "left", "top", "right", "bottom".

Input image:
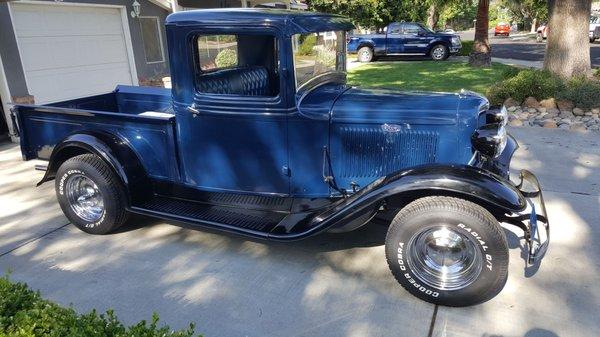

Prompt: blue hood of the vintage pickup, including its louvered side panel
[{"left": 330, "top": 88, "right": 487, "bottom": 188}]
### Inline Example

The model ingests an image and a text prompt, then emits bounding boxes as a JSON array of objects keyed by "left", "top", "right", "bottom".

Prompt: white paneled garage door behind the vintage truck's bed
[{"left": 10, "top": 2, "right": 132, "bottom": 104}]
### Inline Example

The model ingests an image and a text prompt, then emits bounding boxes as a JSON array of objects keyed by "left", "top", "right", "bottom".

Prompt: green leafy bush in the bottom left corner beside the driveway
[{"left": 0, "top": 276, "right": 202, "bottom": 337}]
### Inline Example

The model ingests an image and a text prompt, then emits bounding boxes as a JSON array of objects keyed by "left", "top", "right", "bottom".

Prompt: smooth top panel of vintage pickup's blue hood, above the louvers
[{"left": 331, "top": 88, "right": 460, "bottom": 125}]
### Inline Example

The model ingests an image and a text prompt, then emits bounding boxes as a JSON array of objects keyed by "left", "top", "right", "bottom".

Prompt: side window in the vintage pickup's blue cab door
[{"left": 193, "top": 33, "right": 279, "bottom": 97}]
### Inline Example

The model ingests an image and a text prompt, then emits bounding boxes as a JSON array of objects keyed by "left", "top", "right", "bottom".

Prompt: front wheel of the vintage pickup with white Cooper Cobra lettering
[{"left": 385, "top": 197, "right": 508, "bottom": 306}]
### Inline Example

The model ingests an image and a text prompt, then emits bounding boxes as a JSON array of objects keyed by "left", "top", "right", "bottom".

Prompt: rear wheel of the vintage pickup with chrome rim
[{"left": 55, "top": 154, "right": 127, "bottom": 234}]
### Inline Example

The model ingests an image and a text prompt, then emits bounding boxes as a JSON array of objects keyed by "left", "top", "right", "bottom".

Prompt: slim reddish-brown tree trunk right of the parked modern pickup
[{"left": 469, "top": 0, "right": 492, "bottom": 67}]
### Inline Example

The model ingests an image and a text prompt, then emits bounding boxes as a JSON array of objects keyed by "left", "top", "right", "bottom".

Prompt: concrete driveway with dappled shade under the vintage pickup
[{"left": 0, "top": 128, "right": 600, "bottom": 337}]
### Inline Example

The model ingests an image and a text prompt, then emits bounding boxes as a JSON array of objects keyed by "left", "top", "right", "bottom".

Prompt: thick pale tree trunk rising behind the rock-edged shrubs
[{"left": 544, "top": 0, "right": 592, "bottom": 78}]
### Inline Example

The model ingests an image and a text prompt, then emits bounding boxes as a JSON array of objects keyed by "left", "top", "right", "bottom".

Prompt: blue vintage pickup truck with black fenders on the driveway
[{"left": 13, "top": 10, "right": 549, "bottom": 306}]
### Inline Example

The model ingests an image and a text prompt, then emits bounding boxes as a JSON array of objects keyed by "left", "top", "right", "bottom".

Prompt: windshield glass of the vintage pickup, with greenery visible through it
[{"left": 292, "top": 31, "right": 346, "bottom": 88}]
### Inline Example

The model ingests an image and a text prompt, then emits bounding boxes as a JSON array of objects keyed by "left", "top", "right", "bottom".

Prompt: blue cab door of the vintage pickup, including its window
[{"left": 177, "top": 32, "right": 290, "bottom": 195}]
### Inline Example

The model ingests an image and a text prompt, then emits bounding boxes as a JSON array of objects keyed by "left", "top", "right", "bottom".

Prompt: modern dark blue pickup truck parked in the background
[{"left": 348, "top": 22, "right": 462, "bottom": 62}]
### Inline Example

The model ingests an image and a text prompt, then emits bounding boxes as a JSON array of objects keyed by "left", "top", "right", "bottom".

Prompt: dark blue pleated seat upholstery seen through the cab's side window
[{"left": 198, "top": 67, "right": 271, "bottom": 96}]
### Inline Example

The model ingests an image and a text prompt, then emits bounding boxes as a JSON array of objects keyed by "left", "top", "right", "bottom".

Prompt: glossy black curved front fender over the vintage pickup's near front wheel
[{"left": 270, "top": 164, "right": 526, "bottom": 239}]
